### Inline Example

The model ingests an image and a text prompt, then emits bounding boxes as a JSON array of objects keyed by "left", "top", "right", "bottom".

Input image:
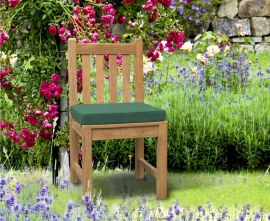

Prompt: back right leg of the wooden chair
[{"left": 135, "top": 138, "right": 144, "bottom": 179}]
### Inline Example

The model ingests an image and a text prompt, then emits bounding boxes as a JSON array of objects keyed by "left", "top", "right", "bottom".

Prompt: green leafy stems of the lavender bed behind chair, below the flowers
[{"left": 148, "top": 84, "right": 270, "bottom": 171}]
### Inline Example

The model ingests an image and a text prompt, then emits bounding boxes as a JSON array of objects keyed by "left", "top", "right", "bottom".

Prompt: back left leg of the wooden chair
[{"left": 70, "top": 127, "right": 80, "bottom": 184}]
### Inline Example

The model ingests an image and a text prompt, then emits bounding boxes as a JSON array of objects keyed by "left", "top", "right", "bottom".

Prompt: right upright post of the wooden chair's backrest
[{"left": 134, "top": 39, "right": 144, "bottom": 102}]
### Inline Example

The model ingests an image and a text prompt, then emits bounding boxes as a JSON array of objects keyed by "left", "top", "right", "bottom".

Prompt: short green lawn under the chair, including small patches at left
[{"left": 13, "top": 170, "right": 270, "bottom": 214}]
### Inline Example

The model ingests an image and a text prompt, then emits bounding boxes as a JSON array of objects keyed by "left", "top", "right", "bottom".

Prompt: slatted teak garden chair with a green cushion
[{"left": 68, "top": 39, "right": 167, "bottom": 199}]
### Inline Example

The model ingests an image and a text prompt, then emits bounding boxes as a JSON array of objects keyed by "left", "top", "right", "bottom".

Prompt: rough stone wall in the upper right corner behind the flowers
[{"left": 212, "top": 0, "right": 270, "bottom": 52}]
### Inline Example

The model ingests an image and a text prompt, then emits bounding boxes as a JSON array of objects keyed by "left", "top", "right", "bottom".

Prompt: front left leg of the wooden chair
[{"left": 82, "top": 129, "right": 92, "bottom": 194}]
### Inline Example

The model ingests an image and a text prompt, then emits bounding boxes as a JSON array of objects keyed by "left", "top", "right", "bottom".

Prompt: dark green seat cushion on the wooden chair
[{"left": 71, "top": 102, "right": 166, "bottom": 125}]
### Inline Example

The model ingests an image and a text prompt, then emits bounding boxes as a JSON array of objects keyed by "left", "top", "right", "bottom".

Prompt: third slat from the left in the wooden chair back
[{"left": 109, "top": 55, "right": 117, "bottom": 103}]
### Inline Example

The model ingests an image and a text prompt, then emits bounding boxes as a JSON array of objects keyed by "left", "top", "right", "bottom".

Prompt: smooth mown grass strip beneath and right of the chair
[{"left": 94, "top": 171, "right": 270, "bottom": 211}]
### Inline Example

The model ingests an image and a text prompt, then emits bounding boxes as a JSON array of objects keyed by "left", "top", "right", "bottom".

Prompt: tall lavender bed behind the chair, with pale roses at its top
[{"left": 146, "top": 44, "right": 270, "bottom": 170}]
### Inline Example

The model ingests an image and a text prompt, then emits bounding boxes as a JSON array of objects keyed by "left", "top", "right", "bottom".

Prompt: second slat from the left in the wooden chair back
[{"left": 96, "top": 55, "right": 104, "bottom": 104}]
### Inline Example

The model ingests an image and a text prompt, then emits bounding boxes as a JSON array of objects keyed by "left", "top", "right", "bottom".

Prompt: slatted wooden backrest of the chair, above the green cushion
[{"left": 68, "top": 38, "right": 144, "bottom": 106}]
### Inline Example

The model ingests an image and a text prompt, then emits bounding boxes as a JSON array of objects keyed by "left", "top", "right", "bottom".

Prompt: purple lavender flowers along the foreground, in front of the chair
[{"left": 0, "top": 166, "right": 270, "bottom": 221}]
